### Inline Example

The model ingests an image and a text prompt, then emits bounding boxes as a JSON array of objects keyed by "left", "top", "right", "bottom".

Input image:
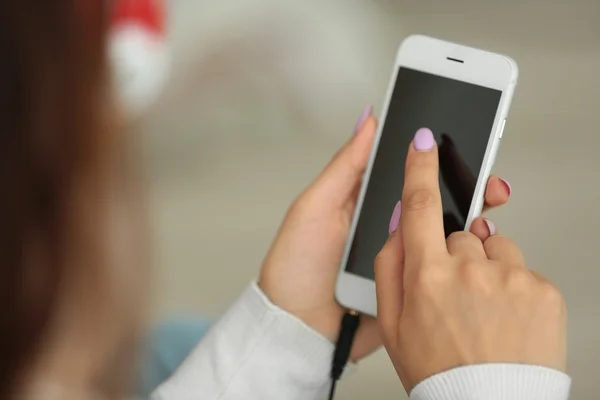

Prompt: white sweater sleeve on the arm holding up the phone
[{"left": 152, "top": 284, "right": 334, "bottom": 400}]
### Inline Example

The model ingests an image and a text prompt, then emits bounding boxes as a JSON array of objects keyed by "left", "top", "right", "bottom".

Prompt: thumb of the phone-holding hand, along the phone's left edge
[{"left": 311, "top": 108, "right": 377, "bottom": 207}]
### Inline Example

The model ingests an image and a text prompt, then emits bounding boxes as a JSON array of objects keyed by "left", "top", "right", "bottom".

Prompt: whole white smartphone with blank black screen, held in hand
[{"left": 336, "top": 35, "right": 518, "bottom": 315}]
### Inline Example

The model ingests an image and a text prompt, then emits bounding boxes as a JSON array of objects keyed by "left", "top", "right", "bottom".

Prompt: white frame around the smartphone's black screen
[{"left": 335, "top": 35, "right": 519, "bottom": 316}]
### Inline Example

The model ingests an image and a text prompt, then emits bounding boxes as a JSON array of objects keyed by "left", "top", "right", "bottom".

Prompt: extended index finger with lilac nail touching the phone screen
[{"left": 402, "top": 128, "right": 448, "bottom": 259}]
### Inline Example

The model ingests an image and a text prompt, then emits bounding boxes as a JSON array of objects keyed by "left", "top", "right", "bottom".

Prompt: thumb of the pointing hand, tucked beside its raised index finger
[{"left": 375, "top": 201, "right": 404, "bottom": 341}]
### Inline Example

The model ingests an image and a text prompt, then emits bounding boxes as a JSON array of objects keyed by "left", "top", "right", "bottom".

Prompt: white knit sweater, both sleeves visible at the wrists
[{"left": 152, "top": 284, "right": 571, "bottom": 400}]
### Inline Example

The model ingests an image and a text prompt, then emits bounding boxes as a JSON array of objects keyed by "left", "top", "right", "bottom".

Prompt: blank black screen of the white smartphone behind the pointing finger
[{"left": 346, "top": 67, "right": 502, "bottom": 279}]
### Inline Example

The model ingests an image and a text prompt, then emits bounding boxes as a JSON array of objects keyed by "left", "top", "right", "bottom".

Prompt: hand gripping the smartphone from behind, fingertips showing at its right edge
[{"left": 259, "top": 111, "right": 510, "bottom": 361}]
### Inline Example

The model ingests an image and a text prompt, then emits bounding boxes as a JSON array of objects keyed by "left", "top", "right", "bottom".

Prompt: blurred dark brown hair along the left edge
[{"left": 0, "top": 0, "right": 110, "bottom": 399}]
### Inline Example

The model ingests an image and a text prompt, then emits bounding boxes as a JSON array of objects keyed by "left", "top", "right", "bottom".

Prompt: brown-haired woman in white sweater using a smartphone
[{"left": 0, "top": 0, "right": 570, "bottom": 400}]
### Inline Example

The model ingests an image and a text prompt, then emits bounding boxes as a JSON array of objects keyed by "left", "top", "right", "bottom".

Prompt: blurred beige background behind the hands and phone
[{"left": 142, "top": 0, "right": 600, "bottom": 399}]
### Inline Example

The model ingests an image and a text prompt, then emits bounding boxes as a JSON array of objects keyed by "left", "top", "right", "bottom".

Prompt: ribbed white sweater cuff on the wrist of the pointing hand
[{"left": 410, "top": 364, "right": 571, "bottom": 400}]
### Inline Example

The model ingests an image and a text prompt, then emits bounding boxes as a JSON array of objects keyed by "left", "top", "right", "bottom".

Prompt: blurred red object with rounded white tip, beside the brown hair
[{"left": 108, "top": 0, "right": 170, "bottom": 119}]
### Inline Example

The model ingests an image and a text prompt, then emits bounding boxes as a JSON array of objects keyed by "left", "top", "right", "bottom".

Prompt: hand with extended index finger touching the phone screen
[{"left": 375, "top": 132, "right": 566, "bottom": 393}]
